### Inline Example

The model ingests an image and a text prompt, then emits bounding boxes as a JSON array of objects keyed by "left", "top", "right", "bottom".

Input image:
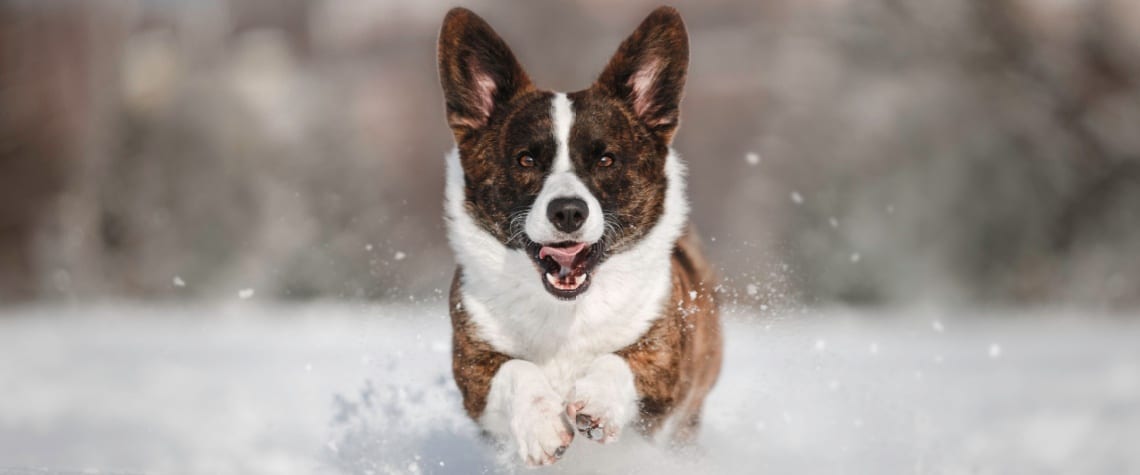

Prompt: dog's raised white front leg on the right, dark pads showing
[{"left": 567, "top": 353, "right": 637, "bottom": 443}]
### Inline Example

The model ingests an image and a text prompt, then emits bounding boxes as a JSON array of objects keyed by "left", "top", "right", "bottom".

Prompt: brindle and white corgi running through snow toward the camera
[{"left": 438, "top": 7, "right": 723, "bottom": 466}]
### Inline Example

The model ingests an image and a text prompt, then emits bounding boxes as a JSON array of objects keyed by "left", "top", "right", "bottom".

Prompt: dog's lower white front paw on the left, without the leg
[{"left": 511, "top": 392, "right": 573, "bottom": 467}]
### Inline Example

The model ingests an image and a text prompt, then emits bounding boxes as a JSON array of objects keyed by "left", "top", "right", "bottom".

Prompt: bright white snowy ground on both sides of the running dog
[{"left": 0, "top": 301, "right": 1140, "bottom": 475}]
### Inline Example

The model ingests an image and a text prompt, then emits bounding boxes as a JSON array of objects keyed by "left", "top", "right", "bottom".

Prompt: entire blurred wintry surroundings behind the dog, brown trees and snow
[{"left": 0, "top": 0, "right": 1140, "bottom": 474}]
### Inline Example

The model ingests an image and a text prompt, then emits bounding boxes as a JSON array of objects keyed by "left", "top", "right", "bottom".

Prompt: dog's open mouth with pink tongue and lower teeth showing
[{"left": 528, "top": 241, "right": 601, "bottom": 300}]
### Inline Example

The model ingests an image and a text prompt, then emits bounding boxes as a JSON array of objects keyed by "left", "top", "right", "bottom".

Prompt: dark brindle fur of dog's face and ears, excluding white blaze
[{"left": 439, "top": 8, "right": 689, "bottom": 255}]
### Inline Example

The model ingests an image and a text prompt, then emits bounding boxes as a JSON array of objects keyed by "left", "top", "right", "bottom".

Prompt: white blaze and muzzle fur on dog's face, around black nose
[{"left": 524, "top": 92, "right": 605, "bottom": 244}]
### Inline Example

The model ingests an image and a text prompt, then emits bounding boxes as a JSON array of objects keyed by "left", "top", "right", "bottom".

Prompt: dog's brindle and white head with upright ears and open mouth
[{"left": 439, "top": 7, "right": 689, "bottom": 300}]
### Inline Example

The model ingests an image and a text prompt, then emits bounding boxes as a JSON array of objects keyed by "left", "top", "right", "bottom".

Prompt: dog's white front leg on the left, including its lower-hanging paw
[{"left": 480, "top": 360, "right": 573, "bottom": 466}]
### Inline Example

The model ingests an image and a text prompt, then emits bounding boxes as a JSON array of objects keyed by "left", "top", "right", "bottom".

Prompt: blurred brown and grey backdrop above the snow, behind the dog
[{"left": 0, "top": 0, "right": 1140, "bottom": 309}]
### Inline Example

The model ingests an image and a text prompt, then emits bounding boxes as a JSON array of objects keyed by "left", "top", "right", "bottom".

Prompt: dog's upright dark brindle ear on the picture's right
[{"left": 595, "top": 7, "right": 689, "bottom": 144}]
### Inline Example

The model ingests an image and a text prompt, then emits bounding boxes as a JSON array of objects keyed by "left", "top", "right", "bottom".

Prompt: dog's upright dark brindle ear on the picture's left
[{"left": 438, "top": 8, "right": 534, "bottom": 142}]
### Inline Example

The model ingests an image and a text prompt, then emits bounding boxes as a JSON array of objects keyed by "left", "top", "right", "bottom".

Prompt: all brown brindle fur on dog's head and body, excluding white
[{"left": 439, "top": 7, "right": 722, "bottom": 442}]
